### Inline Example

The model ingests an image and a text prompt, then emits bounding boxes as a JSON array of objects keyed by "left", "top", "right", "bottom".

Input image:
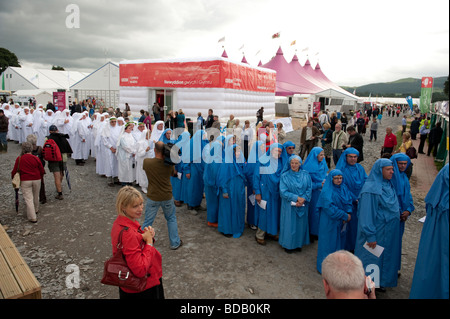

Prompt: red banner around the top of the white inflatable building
[{"left": 120, "top": 60, "right": 276, "bottom": 93}]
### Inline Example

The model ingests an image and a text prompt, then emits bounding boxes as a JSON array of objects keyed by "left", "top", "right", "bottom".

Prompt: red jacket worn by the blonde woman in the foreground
[{"left": 111, "top": 216, "right": 162, "bottom": 293}]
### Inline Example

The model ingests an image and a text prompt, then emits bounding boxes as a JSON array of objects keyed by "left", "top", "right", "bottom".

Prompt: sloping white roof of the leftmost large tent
[{"left": 5, "top": 67, "right": 89, "bottom": 90}]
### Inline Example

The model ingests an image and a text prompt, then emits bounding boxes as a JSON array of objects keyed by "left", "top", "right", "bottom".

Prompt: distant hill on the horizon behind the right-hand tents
[{"left": 342, "top": 76, "right": 447, "bottom": 98}]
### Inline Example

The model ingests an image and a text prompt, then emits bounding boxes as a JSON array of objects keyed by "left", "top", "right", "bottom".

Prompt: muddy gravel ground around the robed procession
[{"left": 0, "top": 117, "right": 426, "bottom": 299}]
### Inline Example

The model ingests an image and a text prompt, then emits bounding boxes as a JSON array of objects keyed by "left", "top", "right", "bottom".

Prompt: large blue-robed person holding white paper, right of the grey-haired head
[{"left": 352, "top": 158, "right": 401, "bottom": 289}]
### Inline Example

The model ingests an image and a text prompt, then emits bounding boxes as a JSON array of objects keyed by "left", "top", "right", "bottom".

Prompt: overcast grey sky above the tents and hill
[{"left": 0, "top": 0, "right": 449, "bottom": 86}]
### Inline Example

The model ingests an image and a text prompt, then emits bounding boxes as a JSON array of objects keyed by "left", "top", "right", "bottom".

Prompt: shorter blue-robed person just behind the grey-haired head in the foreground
[{"left": 317, "top": 169, "right": 355, "bottom": 273}]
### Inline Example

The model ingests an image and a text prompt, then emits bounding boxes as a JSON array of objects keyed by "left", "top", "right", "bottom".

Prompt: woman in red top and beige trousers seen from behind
[{"left": 11, "top": 142, "right": 45, "bottom": 223}]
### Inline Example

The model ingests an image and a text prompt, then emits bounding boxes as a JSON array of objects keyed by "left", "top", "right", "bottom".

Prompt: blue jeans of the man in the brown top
[{"left": 142, "top": 198, "right": 180, "bottom": 249}]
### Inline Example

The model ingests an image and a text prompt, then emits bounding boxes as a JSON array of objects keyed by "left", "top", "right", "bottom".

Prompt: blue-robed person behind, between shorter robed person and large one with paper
[{"left": 336, "top": 147, "right": 367, "bottom": 252}]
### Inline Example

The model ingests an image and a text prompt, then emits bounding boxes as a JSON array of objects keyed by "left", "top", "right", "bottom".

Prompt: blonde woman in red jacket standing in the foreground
[{"left": 111, "top": 186, "right": 164, "bottom": 299}]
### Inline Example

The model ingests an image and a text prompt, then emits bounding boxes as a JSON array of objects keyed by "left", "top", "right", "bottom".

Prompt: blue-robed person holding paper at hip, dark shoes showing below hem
[{"left": 253, "top": 143, "right": 287, "bottom": 245}]
